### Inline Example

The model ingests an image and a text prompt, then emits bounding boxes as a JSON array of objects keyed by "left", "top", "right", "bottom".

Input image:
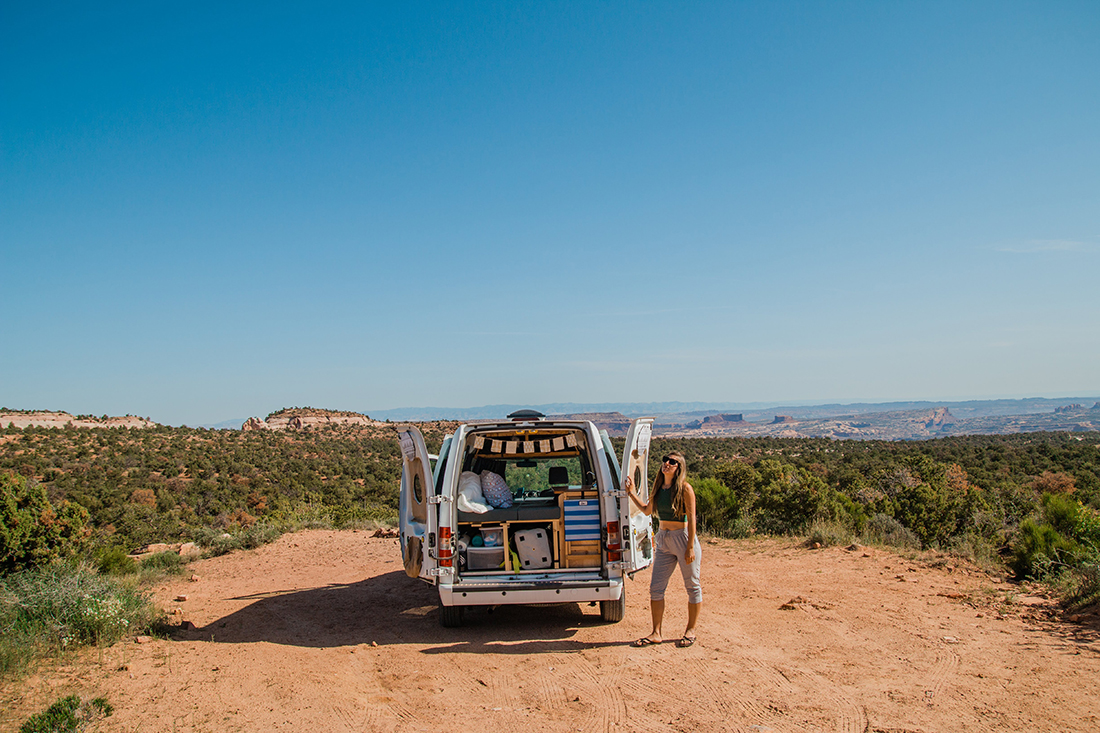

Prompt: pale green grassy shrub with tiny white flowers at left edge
[{"left": 0, "top": 564, "right": 155, "bottom": 675}]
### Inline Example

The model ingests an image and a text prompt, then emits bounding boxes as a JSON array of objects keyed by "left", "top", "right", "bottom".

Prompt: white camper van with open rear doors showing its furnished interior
[{"left": 399, "top": 409, "right": 653, "bottom": 626}]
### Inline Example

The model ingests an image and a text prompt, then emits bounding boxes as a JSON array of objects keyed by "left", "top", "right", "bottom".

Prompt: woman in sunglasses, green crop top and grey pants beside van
[{"left": 624, "top": 444, "right": 703, "bottom": 647}]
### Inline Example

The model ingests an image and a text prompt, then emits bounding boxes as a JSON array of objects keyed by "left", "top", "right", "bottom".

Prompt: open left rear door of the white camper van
[{"left": 398, "top": 427, "right": 437, "bottom": 579}]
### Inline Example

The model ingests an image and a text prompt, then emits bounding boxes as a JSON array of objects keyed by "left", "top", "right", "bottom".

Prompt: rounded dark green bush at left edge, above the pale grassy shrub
[{"left": 0, "top": 473, "right": 89, "bottom": 572}]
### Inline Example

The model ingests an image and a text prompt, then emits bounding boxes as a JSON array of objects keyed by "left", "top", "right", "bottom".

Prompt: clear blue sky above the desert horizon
[{"left": 0, "top": 1, "right": 1100, "bottom": 425}]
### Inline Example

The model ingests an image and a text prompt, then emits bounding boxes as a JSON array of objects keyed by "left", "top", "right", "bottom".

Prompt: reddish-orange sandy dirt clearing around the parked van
[{"left": 0, "top": 530, "right": 1100, "bottom": 733}]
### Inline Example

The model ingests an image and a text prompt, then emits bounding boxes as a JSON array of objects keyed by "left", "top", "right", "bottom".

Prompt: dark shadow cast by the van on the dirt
[{"left": 173, "top": 571, "right": 625, "bottom": 654}]
